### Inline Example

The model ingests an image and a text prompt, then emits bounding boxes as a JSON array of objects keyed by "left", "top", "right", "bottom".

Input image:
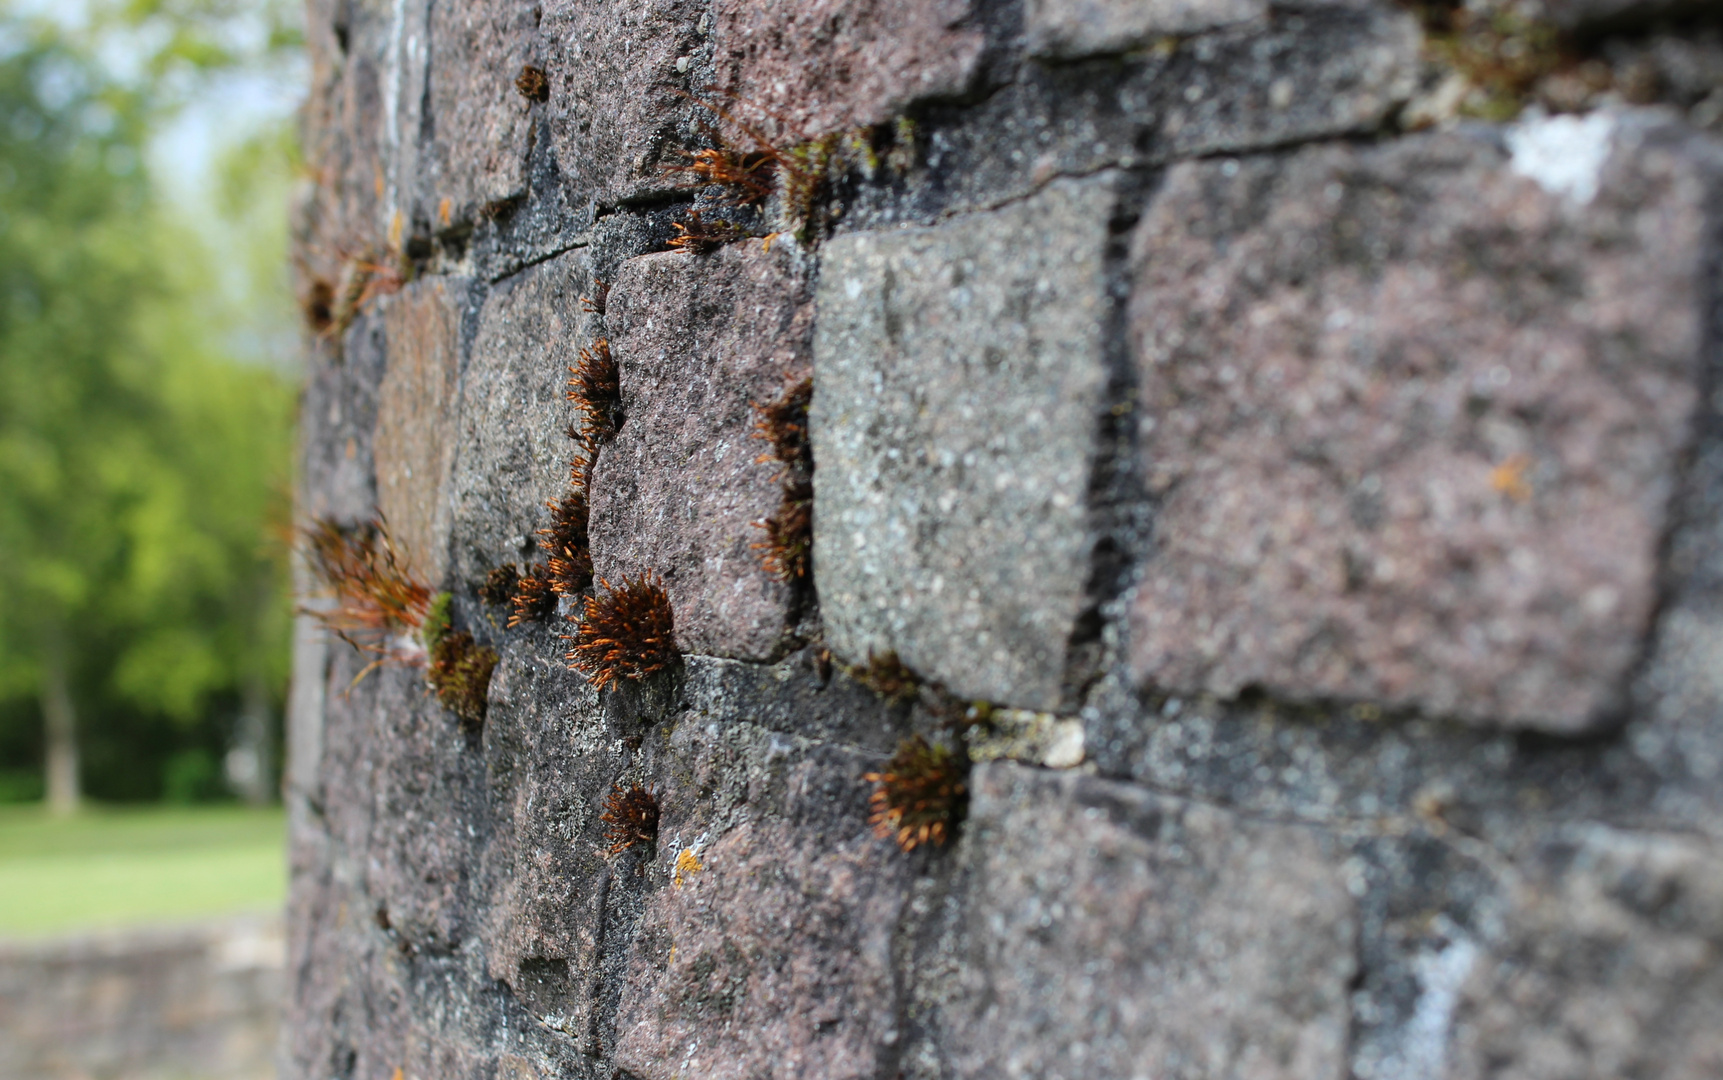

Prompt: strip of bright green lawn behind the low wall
[{"left": 0, "top": 806, "right": 288, "bottom": 939}]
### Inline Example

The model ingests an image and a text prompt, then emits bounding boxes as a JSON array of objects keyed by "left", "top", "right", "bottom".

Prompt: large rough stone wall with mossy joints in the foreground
[{"left": 283, "top": 0, "right": 1723, "bottom": 1080}]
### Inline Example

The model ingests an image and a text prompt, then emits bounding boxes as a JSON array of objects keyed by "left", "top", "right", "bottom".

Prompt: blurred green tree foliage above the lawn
[{"left": 0, "top": 3, "right": 293, "bottom": 798}]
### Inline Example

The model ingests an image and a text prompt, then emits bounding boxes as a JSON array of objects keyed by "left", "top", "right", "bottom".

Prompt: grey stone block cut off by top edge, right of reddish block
[{"left": 1023, "top": 0, "right": 1268, "bottom": 59}]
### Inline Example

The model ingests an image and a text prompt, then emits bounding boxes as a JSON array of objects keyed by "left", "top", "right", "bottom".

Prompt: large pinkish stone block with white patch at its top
[{"left": 1130, "top": 114, "right": 1720, "bottom": 732}]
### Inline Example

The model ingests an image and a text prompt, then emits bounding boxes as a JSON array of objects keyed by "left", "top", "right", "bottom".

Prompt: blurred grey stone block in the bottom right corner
[{"left": 1442, "top": 827, "right": 1723, "bottom": 1080}]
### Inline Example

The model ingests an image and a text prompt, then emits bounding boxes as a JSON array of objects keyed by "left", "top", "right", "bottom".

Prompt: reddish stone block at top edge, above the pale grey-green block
[{"left": 715, "top": 0, "right": 986, "bottom": 138}]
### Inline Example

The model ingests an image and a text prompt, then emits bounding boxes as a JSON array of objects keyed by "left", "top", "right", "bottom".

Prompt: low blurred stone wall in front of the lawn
[{"left": 0, "top": 916, "right": 284, "bottom": 1080}]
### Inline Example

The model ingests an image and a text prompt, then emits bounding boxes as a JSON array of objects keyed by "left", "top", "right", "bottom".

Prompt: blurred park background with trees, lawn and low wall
[{"left": 0, "top": 0, "right": 305, "bottom": 1078}]
